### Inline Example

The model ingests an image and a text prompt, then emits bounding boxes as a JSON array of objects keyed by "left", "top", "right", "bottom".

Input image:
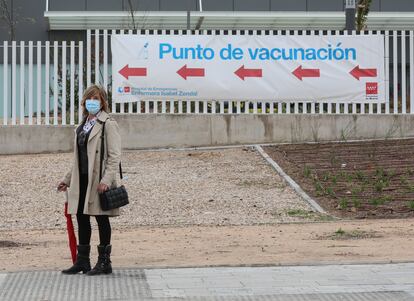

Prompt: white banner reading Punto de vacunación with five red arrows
[{"left": 112, "top": 35, "right": 385, "bottom": 102}]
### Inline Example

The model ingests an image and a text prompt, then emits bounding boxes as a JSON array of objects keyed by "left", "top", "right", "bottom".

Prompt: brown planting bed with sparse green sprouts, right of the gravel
[{"left": 264, "top": 139, "right": 414, "bottom": 218}]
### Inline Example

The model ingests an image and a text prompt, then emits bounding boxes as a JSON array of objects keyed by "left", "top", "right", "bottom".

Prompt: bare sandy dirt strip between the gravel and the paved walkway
[{"left": 0, "top": 219, "right": 414, "bottom": 272}]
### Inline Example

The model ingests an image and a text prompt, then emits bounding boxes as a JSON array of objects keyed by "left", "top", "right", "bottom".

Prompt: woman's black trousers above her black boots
[{"left": 76, "top": 174, "right": 111, "bottom": 246}]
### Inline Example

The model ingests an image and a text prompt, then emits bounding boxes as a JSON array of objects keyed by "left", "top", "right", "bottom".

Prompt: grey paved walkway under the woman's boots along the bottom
[{"left": 0, "top": 263, "right": 414, "bottom": 301}]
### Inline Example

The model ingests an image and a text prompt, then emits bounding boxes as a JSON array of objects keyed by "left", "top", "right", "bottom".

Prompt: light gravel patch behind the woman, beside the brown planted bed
[{"left": 0, "top": 148, "right": 311, "bottom": 230}]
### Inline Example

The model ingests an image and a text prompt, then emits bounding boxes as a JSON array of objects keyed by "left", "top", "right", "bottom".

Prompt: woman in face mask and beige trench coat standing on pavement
[{"left": 58, "top": 85, "right": 121, "bottom": 275}]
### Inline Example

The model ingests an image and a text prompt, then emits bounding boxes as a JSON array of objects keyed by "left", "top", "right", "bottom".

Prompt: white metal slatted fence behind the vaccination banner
[{"left": 0, "top": 30, "right": 414, "bottom": 125}]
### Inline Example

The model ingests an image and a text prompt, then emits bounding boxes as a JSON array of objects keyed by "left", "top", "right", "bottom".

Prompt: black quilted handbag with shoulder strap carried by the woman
[{"left": 99, "top": 122, "right": 129, "bottom": 211}]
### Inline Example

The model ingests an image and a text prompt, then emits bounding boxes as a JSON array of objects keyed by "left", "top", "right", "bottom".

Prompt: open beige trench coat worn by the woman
[{"left": 62, "top": 111, "right": 121, "bottom": 216}]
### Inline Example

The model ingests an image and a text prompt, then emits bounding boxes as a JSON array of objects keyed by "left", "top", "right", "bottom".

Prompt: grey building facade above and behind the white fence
[{"left": 0, "top": 0, "right": 414, "bottom": 41}]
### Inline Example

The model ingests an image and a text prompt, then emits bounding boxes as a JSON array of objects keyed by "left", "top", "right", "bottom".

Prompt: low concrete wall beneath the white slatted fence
[{"left": 0, "top": 114, "right": 414, "bottom": 154}]
